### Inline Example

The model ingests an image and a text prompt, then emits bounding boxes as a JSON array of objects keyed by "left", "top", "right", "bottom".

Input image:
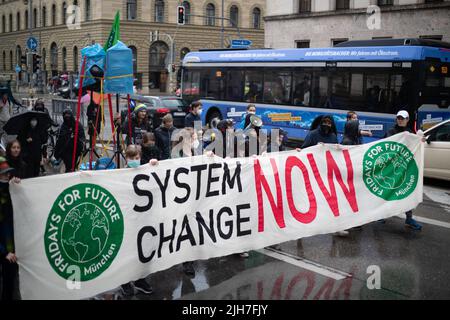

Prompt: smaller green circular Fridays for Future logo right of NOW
[{"left": 363, "top": 141, "right": 419, "bottom": 201}]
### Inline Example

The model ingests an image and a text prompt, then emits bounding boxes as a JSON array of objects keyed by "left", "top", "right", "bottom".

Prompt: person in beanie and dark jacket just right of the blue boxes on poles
[{"left": 121, "top": 104, "right": 152, "bottom": 145}]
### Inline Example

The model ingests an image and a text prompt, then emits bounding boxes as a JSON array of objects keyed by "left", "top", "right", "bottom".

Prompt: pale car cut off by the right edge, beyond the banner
[{"left": 424, "top": 119, "right": 450, "bottom": 181}]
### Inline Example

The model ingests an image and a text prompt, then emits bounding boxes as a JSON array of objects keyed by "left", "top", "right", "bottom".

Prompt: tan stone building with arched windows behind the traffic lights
[{"left": 0, "top": 0, "right": 265, "bottom": 94}]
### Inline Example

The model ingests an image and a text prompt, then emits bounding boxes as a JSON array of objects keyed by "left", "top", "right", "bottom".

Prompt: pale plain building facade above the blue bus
[{"left": 264, "top": 0, "right": 450, "bottom": 48}]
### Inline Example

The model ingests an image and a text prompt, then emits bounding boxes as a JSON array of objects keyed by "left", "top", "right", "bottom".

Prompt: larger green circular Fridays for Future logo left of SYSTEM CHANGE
[{"left": 45, "top": 184, "right": 124, "bottom": 281}]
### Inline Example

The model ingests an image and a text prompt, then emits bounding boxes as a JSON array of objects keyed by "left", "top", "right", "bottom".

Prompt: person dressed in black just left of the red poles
[{"left": 55, "top": 109, "right": 86, "bottom": 172}]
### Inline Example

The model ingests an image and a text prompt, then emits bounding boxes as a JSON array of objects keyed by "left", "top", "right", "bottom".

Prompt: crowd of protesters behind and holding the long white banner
[{"left": 0, "top": 95, "right": 422, "bottom": 300}]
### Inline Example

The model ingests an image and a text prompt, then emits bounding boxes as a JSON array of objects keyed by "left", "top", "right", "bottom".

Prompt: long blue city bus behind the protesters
[{"left": 181, "top": 39, "right": 450, "bottom": 143}]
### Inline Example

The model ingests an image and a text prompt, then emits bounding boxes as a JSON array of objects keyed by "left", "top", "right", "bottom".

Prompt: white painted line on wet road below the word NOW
[{"left": 256, "top": 248, "right": 352, "bottom": 280}]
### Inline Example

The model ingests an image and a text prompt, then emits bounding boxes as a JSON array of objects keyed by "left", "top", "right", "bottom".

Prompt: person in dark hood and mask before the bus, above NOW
[{"left": 301, "top": 115, "right": 338, "bottom": 149}]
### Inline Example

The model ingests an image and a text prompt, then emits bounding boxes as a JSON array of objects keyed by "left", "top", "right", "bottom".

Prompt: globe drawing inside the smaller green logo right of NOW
[{"left": 373, "top": 152, "right": 408, "bottom": 189}]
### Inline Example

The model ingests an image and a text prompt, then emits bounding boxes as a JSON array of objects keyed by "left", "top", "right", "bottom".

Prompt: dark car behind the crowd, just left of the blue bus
[{"left": 144, "top": 96, "right": 189, "bottom": 128}]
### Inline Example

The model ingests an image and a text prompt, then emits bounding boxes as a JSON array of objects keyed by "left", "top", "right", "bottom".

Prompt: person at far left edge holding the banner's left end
[{"left": 0, "top": 157, "right": 20, "bottom": 301}]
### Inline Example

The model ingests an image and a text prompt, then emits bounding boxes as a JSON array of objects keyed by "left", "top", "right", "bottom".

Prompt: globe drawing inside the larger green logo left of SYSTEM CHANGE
[{"left": 62, "top": 203, "right": 109, "bottom": 263}]
